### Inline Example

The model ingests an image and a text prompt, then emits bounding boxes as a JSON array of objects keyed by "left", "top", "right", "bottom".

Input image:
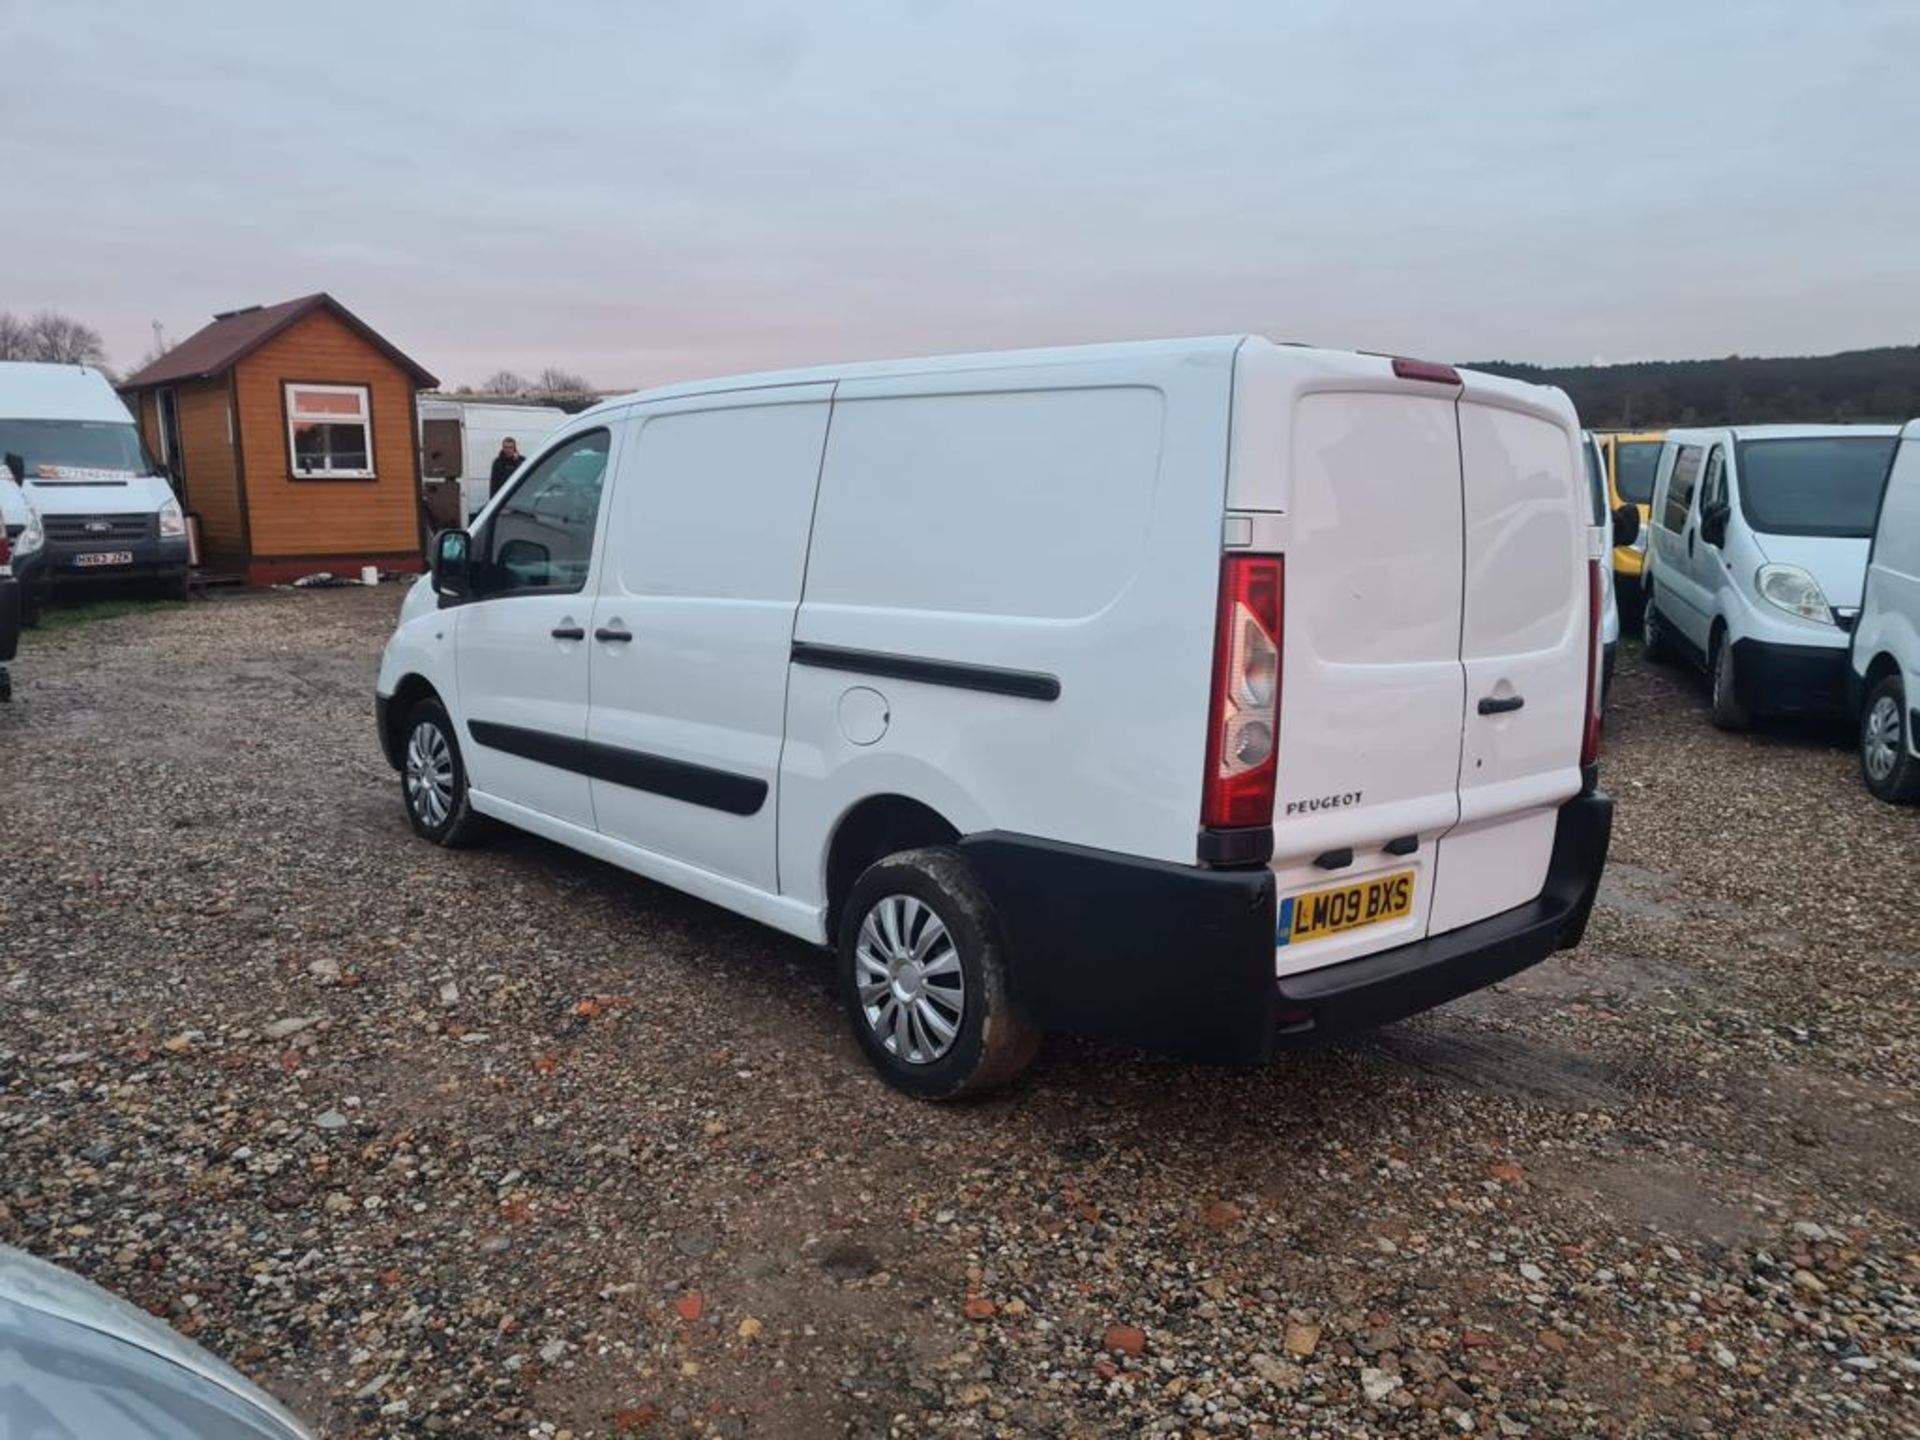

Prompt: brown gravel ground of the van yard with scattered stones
[{"left": 0, "top": 589, "right": 1920, "bottom": 1440}]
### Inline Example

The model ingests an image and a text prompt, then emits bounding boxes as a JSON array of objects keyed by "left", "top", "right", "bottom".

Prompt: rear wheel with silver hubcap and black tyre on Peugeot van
[{"left": 839, "top": 845, "right": 1041, "bottom": 1100}]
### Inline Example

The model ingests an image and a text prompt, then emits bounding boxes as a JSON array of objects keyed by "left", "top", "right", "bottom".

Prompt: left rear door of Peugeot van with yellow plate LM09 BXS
[{"left": 1227, "top": 353, "right": 1463, "bottom": 973}]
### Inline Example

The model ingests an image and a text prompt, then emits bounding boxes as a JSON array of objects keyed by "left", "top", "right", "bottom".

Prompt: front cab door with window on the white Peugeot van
[{"left": 453, "top": 420, "right": 620, "bottom": 828}]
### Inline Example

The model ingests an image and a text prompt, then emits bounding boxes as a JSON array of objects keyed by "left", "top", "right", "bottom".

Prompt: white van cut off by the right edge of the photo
[{"left": 1847, "top": 420, "right": 1920, "bottom": 804}]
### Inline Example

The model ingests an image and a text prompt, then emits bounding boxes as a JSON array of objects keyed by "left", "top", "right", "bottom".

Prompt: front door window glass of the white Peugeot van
[{"left": 486, "top": 430, "right": 609, "bottom": 595}]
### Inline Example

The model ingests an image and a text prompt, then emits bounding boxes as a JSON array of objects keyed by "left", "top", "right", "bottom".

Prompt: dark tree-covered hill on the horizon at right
[{"left": 1473, "top": 346, "right": 1920, "bottom": 430}]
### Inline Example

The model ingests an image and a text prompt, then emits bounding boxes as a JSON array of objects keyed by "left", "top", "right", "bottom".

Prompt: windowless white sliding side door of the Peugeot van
[{"left": 588, "top": 384, "right": 833, "bottom": 893}]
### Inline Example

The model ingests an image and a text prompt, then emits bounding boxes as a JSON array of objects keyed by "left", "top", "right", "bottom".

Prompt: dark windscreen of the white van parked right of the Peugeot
[{"left": 1740, "top": 436, "right": 1899, "bottom": 540}]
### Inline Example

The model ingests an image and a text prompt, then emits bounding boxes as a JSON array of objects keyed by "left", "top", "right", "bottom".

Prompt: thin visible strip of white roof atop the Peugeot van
[{"left": 574, "top": 334, "right": 1546, "bottom": 419}]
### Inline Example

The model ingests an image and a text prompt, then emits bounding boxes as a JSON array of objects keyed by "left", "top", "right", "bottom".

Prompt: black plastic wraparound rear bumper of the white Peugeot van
[{"left": 960, "top": 793, "right": 1613, "bottom": 1064}]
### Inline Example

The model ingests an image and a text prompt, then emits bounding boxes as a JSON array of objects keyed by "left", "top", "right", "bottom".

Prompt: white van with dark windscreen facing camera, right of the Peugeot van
[{"left": 1644, "top": 424, "right": 1899, "bottom": 730}]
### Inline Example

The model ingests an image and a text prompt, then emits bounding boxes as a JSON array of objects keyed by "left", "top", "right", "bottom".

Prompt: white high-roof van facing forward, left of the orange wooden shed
[{"left": 0, "top": 361, "right": 186, "bottom": 593}]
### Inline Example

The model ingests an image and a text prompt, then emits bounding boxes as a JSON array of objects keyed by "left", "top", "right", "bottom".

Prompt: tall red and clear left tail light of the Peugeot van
[{"left": 1200, "top": 555, "right": 1284, "bottom": 828}]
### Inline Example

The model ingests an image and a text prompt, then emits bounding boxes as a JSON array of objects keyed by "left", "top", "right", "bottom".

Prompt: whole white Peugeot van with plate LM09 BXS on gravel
[{"left": 376, "top": 338, "right": 1613, "bottom": 1098}]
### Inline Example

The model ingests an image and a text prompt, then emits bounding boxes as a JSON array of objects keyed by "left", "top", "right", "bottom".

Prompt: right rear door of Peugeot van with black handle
[{"left": 1428, "top": 374, "right": 1603, "bottom": 935}]
